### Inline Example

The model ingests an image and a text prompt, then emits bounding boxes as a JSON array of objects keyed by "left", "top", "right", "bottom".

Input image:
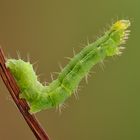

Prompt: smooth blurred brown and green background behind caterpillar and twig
[{"left": 0, "top": 0, "right": 140, "bottom": 140}]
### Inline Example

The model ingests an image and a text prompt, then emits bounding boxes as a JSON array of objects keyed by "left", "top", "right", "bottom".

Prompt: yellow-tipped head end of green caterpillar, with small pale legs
[{"left": 106, "top": 20, "right": 130, "bottom": 56}]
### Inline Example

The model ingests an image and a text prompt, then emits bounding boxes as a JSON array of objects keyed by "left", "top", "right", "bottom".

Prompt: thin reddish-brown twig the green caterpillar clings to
[{"left": 0, "top": 48, "right": 49, "bottom": 140}]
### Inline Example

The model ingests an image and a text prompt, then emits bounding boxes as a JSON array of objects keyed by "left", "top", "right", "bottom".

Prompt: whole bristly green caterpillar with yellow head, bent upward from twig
[{"left": 6, "top": 20, "right": 130, "bottom": 113}]
